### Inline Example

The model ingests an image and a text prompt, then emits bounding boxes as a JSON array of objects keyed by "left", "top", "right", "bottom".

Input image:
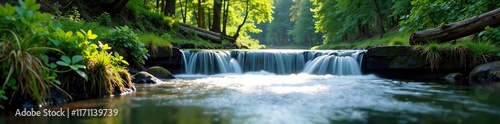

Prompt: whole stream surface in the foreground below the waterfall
[{"left": 0, "top": 72, "right": 500, "bottom": 124}]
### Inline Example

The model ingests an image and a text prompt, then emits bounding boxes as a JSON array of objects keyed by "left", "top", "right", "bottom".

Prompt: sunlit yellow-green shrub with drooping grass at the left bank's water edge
[{"left": 58, "top": 30, "right": 131, "bottom": 97}]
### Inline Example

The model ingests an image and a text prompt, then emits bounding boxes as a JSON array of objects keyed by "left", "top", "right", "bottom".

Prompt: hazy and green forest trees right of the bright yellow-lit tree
[{"left": 252, "top": 0, "right": 500, "bottom": 47}]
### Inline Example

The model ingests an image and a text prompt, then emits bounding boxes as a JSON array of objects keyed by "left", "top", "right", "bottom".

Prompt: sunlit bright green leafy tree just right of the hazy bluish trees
[{"left": 312, "top": 0, "right": 376, "bottom": 42}]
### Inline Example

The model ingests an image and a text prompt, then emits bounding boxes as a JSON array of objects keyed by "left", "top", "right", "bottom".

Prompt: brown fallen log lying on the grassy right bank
[{"left": 410, "top": 8, "right": 500, "bottom": 45}]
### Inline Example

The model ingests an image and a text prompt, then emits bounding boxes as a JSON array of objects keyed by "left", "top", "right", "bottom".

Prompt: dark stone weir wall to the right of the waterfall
[{"left": 361, "top": 46, "right": 471, "bottom": 80}]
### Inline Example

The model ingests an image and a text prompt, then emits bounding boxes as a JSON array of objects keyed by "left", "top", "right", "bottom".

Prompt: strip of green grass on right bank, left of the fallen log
[{"left": 311, "top": 31, "right": 410, "bottom": 50}]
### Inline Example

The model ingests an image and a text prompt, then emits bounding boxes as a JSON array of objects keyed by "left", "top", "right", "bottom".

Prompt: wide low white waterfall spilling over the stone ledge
[{"left": 182, "top": 50, "right": 364, "bottom": 75}]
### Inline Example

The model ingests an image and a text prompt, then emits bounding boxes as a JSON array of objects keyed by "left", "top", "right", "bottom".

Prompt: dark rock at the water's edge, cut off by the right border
[{"left": 469, "top": 61, "right": 500, "bottom": 84}]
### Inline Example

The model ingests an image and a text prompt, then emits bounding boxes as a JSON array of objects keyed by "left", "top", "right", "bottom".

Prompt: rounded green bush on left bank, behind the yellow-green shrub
[{"left": 103, "top": 26, "right": 149, "bottom": 64}]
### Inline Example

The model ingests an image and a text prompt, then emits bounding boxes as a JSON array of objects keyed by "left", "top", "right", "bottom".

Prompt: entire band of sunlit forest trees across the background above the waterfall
[{"left": 3, "top": 0, "right": 500, "bottom": 49}]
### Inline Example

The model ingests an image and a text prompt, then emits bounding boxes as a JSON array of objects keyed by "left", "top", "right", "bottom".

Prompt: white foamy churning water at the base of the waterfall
[{"left": 137, "top": 72, "right": 452, "bottom": 123}]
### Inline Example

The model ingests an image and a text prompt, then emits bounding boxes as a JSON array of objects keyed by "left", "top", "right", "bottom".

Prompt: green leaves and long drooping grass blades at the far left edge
[{"left": 0, "top": 0, "right": 65, "bottom": 104}]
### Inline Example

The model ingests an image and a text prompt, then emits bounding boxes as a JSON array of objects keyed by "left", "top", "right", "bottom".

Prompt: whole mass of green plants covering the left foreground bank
[{"left": 0, "top": 0, "right": 134, "bottom": 107}]
